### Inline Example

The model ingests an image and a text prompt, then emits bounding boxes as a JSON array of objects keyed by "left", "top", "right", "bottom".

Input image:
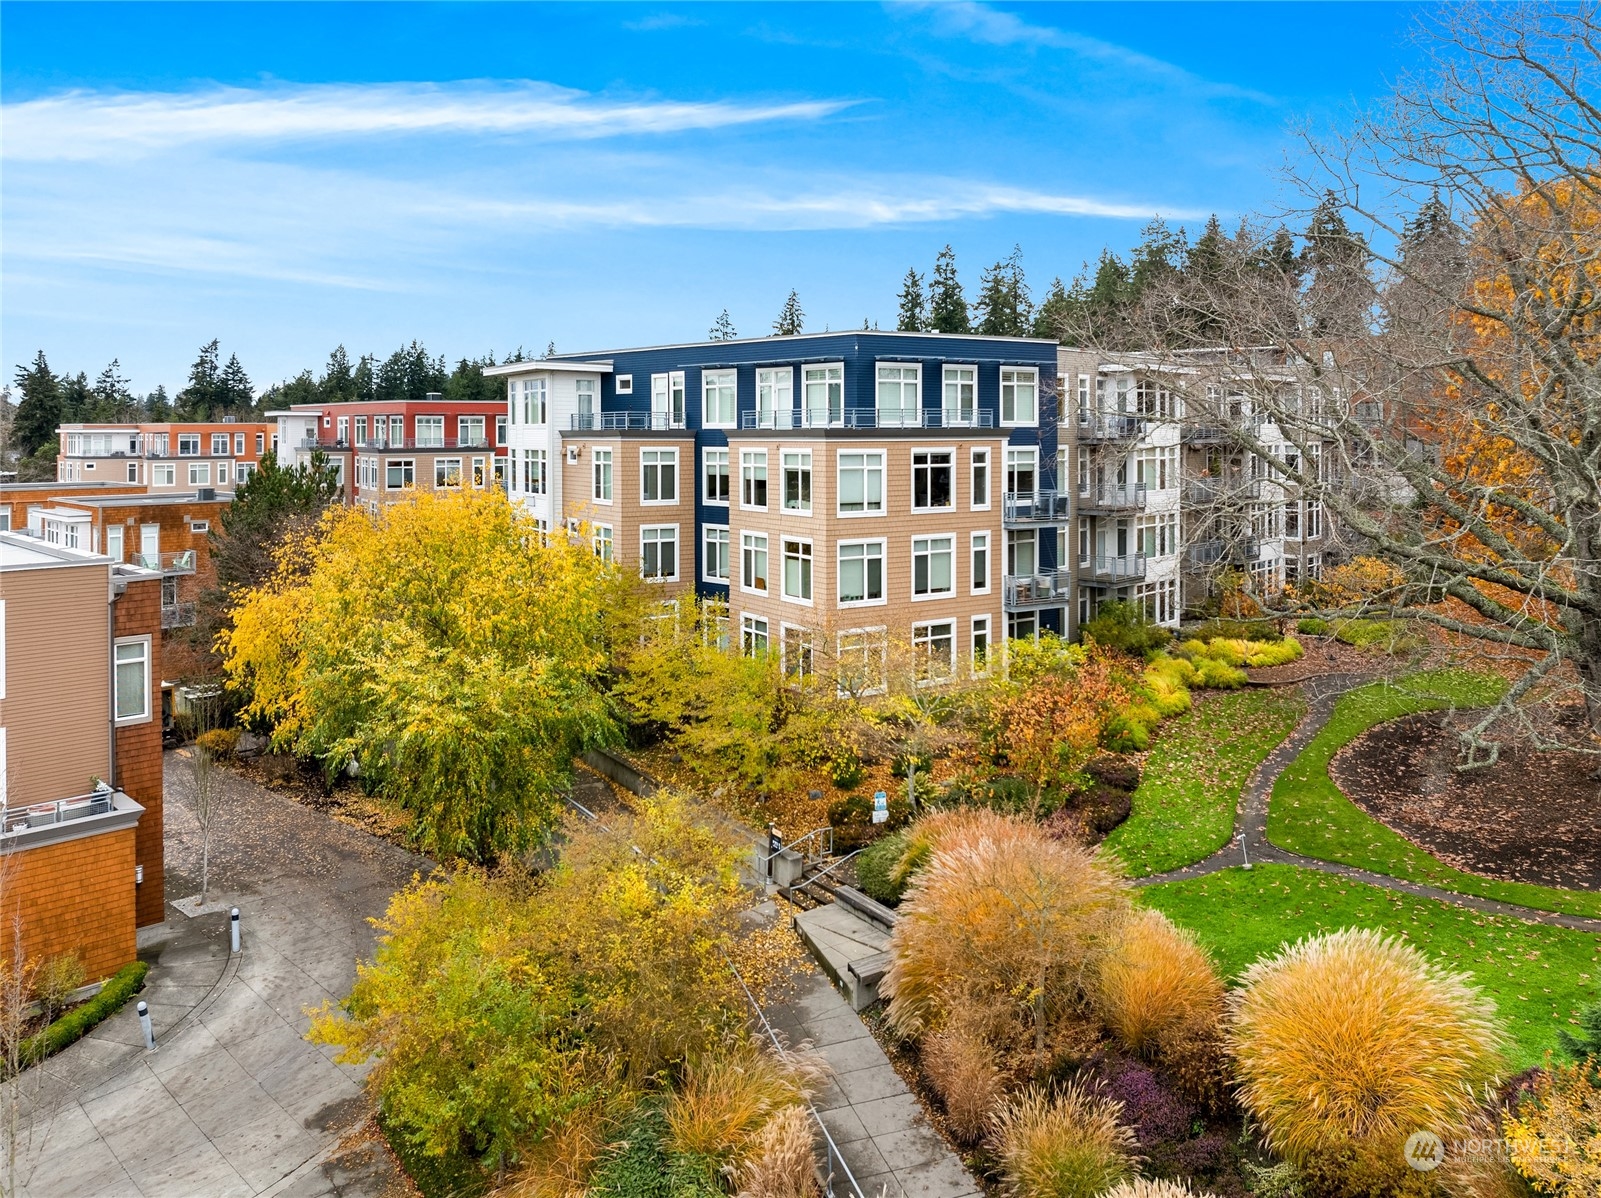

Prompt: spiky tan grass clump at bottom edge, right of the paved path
[{"left": 993, "top": 1084, "right": 1135, "bottom": 1198}]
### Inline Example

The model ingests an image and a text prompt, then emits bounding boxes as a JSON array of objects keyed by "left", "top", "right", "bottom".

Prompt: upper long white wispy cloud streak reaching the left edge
[{"left": 0, "top": 80, "right": 855, "bottom": 162}]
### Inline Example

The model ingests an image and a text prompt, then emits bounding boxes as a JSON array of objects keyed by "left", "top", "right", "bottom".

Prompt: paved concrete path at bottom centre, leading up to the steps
[{"left": 765, "top": 948, "right": 981, "bottom": 1198}]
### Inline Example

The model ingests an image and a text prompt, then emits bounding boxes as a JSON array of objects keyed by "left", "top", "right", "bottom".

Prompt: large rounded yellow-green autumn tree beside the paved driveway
[{"left": 218, "top": 490, "right": 631, "bottom": 862}]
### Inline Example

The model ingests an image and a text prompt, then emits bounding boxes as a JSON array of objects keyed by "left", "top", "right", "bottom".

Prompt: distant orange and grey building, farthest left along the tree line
[{"left": 56, "top": 420, "right": 277, "bottom": 495}]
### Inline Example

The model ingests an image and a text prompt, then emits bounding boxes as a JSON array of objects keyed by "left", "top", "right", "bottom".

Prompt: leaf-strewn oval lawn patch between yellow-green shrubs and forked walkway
[{"left": 1106, "top": 689, "right": 1306, "bottom": 878}]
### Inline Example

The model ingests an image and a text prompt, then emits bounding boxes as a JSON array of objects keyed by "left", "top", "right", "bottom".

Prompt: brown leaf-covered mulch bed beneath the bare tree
[{"left": 1329, "top": 713, "right": 1601, "bottom": 890}]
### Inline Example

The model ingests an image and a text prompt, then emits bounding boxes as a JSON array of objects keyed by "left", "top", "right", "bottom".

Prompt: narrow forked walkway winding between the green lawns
[{"left": 1135, "top": 674, "right": 1601, "bottom": 934}]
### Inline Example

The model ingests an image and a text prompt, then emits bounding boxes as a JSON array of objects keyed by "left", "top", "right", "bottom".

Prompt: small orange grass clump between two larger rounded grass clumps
[{"left": 1090, "top": 910, "right": 1223, "bottom": 1057}]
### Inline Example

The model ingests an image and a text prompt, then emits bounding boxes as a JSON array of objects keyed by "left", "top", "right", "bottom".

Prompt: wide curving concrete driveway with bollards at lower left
[{"left": 16, "top": 754, "right": 429, "bottom": 1198}]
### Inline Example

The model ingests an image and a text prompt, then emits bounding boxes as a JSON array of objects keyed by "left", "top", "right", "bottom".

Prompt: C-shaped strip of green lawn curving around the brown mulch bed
[{"left": 1268, "top": 669, "right": 1601, "bottom": 916}]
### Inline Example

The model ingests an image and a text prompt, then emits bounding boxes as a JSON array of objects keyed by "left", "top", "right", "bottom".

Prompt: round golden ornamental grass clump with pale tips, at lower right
[{"left": 1230, "top": 929, "right": 1502, "bottom": 1192}]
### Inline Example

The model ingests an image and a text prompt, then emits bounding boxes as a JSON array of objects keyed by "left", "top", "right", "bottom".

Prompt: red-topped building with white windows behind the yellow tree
[{"left": 267, "top": 392, "right": 508, "bottom": 511}]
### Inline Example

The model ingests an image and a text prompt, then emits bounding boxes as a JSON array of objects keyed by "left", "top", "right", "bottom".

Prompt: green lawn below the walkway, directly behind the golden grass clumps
[{"left": 1142, "top": 865, "right": 1601, "bottom": 1068}]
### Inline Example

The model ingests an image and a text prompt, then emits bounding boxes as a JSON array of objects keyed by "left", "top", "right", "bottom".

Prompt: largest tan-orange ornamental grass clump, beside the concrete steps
[{"left": 881, "top": 817, "right": 1129, "bottom": 1057}]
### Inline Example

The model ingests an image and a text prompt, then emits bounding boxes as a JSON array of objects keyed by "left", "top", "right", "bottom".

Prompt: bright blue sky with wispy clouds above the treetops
[{"left": 0, "top": 3, "right": 1418, "bottom": 391}]
